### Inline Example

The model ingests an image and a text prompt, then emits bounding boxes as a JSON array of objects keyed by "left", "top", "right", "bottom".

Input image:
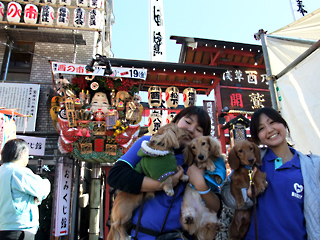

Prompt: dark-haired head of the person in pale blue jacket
[{"left": 1, "top": 138, "right": 29, "bottom": 163}]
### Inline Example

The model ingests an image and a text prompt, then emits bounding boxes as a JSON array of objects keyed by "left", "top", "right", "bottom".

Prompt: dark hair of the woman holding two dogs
[{"left": 172, "top": 106, "right": 211, "bottom": 136}]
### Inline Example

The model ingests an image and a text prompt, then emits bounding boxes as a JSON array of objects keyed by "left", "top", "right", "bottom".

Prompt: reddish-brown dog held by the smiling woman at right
[{"left": 228, "top": 140, "right": 268, "bottom": 240}]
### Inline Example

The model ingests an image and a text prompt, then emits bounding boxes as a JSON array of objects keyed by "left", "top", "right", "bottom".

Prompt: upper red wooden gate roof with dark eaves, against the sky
[{"left": 170, "top": 36, "right": 265, "bottom": 69}]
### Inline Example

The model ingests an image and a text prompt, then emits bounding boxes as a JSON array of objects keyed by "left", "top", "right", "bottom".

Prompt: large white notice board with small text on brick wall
[{"left": 0, "top": 83, "right": 40, "bottom": 132}]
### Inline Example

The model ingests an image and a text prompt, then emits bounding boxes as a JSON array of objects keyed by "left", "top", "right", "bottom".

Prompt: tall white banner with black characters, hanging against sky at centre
[{"left": 149, "top": 0, "right": 166, "bottom": 62}]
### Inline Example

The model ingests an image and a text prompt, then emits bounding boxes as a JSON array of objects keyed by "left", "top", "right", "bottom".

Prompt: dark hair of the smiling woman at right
[{"left": 250, "top": 107, "right": 290, "bottom": 144}]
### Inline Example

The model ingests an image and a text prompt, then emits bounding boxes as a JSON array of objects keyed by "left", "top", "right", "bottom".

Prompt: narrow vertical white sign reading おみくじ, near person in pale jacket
[{"left": 54, "top": 157, "right": 72, "bottom": 237}]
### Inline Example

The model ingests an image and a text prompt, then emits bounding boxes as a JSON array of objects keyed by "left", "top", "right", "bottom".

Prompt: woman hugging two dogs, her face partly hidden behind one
[{"left": 107, "top": 106, "right": 224, "bottom": 240}]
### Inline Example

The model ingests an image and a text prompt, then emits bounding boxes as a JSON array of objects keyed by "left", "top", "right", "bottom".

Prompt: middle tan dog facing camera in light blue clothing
[{"left": 180, "top": 136, "right": 222, "bottom": 240}]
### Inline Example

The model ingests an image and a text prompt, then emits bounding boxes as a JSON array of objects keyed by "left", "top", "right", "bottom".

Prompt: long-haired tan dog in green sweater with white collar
[{"left": 107, "top": 123, "right": 189, "bottom": 240}]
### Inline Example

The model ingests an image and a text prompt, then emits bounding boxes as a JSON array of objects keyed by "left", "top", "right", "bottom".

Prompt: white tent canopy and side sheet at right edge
[{"left": 266, "top": 9, "right": 320, "bottom": 155}]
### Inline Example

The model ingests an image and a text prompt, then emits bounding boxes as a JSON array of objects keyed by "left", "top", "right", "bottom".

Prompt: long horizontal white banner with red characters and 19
[{"left": 52, "top": 62, "right": 147, "bottom": 80}]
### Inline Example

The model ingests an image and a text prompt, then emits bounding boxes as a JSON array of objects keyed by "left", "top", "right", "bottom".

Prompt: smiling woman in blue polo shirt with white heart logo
[{"left": 221, "top": 108, "right": 320, "bottom": 240}]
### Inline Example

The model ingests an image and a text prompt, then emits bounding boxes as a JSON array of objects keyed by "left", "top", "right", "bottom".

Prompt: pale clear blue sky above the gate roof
[{"left": 111, "top": 0, "right": 320, "bottom": 62}]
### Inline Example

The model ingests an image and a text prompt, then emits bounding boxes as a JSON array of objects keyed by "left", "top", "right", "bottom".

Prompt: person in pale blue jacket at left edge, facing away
[{"left": 0, "top": 139, "right": 51, "bottom": 240}]
